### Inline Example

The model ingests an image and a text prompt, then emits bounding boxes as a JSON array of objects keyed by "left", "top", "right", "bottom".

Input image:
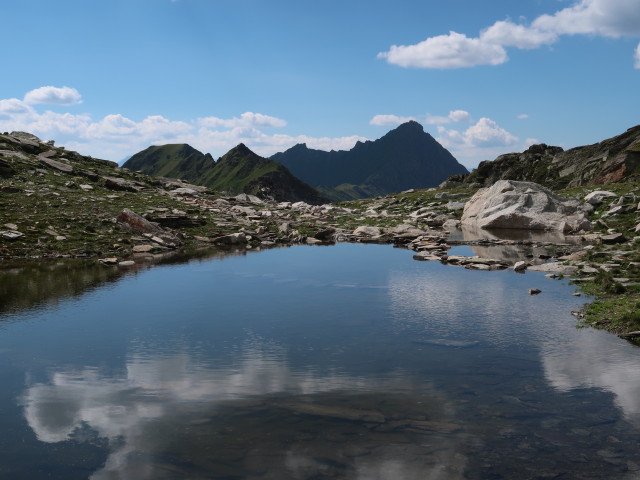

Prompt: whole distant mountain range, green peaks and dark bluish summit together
[{"left": 123, "top": 121, "right": 468, "bottom": 203}]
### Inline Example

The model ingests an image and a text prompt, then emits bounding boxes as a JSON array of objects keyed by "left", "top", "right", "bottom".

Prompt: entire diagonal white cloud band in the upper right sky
[{"left": 378, "top": 0, "right": 640, "bottom": 69}]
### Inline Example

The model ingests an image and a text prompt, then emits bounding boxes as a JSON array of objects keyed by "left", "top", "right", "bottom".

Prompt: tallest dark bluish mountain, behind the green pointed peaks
[{"left": 271, "top": 121, "right": 468, "bottom": 200}]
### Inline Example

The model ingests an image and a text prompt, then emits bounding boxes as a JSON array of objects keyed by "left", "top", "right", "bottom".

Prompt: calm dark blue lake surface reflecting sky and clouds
[{"left": 0, "top": 244, "right": 640, "bottom": 480}]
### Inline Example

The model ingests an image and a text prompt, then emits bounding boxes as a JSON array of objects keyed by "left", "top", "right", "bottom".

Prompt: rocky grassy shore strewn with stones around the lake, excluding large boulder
[{"left": 0, "top": 134, "right": 640, "bottom": 339}]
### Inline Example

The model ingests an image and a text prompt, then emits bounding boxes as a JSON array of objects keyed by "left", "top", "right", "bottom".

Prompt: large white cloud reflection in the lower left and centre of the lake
[{"left": 23, "top": 340, "right": 464, "bottom": 480}]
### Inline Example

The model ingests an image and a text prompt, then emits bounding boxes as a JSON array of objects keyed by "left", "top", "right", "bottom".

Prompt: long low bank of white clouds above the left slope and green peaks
[{"left": 0, "top": 87, "right": 367, "bottom": 161}]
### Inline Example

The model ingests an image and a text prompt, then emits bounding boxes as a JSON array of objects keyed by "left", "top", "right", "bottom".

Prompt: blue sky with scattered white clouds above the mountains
[{"left": 0, "top": 0, "right": 640, "bottom": 168}]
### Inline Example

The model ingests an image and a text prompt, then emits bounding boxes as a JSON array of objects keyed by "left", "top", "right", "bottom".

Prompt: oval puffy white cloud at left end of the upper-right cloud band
[{"left": 378, "top": 32, "right": 508, "bottom": 69}]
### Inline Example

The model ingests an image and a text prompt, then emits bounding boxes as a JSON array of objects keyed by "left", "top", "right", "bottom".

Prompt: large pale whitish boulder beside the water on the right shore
[{"left": 461, "top": 180, "right": 593, "bottom": 233}]
